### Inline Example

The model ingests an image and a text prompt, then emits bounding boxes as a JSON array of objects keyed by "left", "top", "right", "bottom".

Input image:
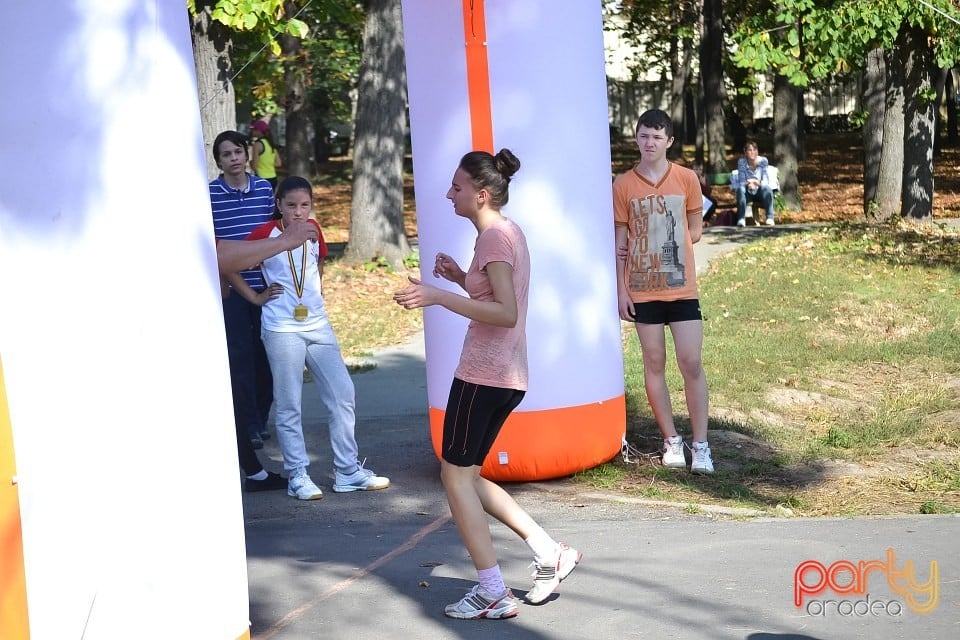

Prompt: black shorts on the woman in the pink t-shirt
[{"left": 441, "top": 378, "right": 525, "bottom": 467}]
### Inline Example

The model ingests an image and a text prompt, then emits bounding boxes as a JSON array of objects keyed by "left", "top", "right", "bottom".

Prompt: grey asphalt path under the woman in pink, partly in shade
[{"left": 243, "top": 225, "right": 960, "bottom": 640}]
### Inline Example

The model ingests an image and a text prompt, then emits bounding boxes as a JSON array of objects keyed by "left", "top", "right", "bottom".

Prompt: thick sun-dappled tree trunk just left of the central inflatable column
[{"left": 345, "top": 0, "right": 410, "bottom": 266}]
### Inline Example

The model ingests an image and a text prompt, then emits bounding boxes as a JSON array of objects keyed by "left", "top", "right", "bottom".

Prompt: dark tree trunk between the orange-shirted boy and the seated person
[{"left": 700, "top": 0, "right": 729, "bottom": 173}]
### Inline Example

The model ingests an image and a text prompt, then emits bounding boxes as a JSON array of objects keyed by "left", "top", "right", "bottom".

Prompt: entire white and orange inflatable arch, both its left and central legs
[{"left": 0, "top": 0, "right": 624, "bottom": 640}]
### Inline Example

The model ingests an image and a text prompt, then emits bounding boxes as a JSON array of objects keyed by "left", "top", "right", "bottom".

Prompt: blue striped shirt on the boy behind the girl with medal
[{"left": 210, "top": 174, "right": 275, "bottom": 289}]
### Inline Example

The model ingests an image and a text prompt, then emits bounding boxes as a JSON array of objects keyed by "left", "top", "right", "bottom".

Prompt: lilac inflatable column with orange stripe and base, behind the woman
[{"left": 403, "top": 0, "right": 626, "bottom": 480}]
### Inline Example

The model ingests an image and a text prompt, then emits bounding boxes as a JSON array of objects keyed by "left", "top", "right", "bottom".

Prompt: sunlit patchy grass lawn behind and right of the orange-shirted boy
[{"left": 581, "top": 224, "right": 960, "bottom": 515}]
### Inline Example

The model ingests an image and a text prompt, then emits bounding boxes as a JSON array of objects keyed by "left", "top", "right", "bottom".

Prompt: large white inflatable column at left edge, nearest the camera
[{"left": 0, "top": 0, "right": 249, "bottom": 640}]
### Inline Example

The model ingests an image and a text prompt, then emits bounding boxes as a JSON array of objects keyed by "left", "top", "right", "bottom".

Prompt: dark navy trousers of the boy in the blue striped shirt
[{"left": 223, "top": 293, "right": 273, "bottom": 439}]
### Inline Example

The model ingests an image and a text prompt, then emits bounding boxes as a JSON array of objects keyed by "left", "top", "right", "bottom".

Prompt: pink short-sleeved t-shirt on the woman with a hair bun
[{"left": 454, "top": 218, "right": 530, "bottom": 391}]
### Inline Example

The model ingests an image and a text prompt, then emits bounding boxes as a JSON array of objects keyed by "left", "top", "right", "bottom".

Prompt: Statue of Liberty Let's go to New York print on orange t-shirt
[{"left": 627, "top": 194, "right": 687, "bottom": 292}]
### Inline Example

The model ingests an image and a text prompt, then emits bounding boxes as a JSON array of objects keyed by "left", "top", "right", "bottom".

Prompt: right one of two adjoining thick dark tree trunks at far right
[{"left": 900, "top": 27, "right": 936, "bottom": 220}]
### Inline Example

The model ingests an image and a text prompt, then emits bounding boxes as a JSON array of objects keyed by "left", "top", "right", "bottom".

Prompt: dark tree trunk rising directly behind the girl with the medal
[{"left": 280, "top": 2, "right": 313, "bottom": 177}]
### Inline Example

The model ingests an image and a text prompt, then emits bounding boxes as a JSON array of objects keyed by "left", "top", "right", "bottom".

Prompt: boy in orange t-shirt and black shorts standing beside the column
[{"left": 613, "top": 109, "right": 713, "bottom": 474}]
